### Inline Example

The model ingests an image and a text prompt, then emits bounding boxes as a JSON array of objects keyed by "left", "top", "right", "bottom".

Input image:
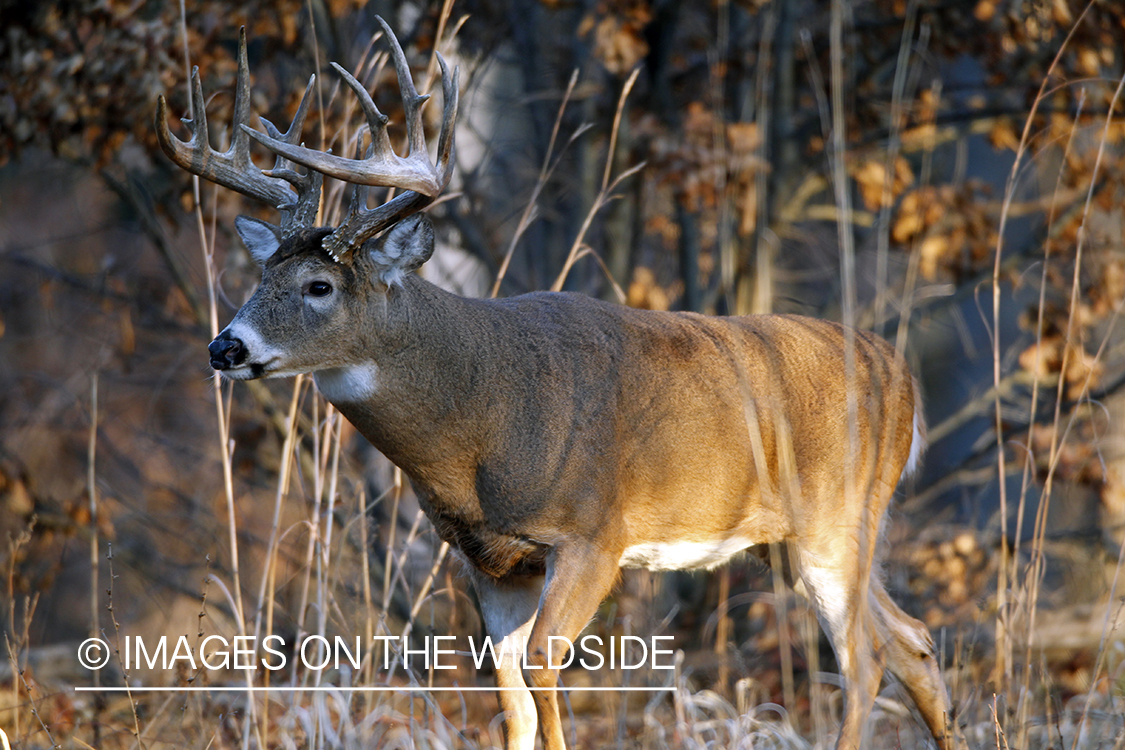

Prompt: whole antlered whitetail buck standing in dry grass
[{"left": 155, "top": 18, "right": 952, "bottom": 750}]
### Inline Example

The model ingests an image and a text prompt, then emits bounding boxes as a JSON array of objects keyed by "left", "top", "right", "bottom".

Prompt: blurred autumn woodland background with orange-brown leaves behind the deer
[{"left": 0, "top": 0, "right": 1125, "bottom": 747}]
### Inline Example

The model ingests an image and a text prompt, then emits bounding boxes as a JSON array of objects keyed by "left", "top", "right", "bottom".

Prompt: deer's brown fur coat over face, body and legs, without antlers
[{"left": 211, "top": 219, "right": 948, "bottom": 750}]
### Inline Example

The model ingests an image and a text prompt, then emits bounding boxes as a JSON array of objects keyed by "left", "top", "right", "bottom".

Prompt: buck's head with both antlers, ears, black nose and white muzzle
[{"left": 156, "top": 18, "right": 458, "bottom": 380}]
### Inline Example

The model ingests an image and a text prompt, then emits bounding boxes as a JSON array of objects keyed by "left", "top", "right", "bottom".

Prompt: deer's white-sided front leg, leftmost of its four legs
[{"left": 471, "top": 570, "right": 543, "bottom": 750}]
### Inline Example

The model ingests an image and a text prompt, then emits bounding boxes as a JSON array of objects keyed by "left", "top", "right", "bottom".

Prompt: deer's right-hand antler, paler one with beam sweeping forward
[{"left": 242, "top": 16, "right": 458, "bottom": 260}]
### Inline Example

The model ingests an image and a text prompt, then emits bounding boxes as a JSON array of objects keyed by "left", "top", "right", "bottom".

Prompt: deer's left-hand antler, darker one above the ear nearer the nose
[{"left": 156, "top": 27, "right": 324, "bottom": 236}]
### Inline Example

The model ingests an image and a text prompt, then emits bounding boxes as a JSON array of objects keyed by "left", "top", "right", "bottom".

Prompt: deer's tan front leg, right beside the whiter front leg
[{"left": 527, "top": 541, "right": 620, "bottom": 750}]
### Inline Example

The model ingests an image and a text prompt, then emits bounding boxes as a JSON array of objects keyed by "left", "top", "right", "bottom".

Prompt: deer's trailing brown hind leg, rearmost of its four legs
[{"left": 871, "top": 579, "right": 953, "bottom": 750}]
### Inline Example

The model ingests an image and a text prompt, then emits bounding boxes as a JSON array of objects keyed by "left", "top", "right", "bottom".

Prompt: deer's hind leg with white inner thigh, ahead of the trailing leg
[{"left": 798, "top": 544, "right": 883, "bottom": 750}]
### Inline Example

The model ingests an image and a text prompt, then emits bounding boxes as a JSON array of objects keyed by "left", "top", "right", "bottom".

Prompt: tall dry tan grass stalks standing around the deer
[{"left": 7, "top": 0, "right": 1125, "bottom": 750}]
